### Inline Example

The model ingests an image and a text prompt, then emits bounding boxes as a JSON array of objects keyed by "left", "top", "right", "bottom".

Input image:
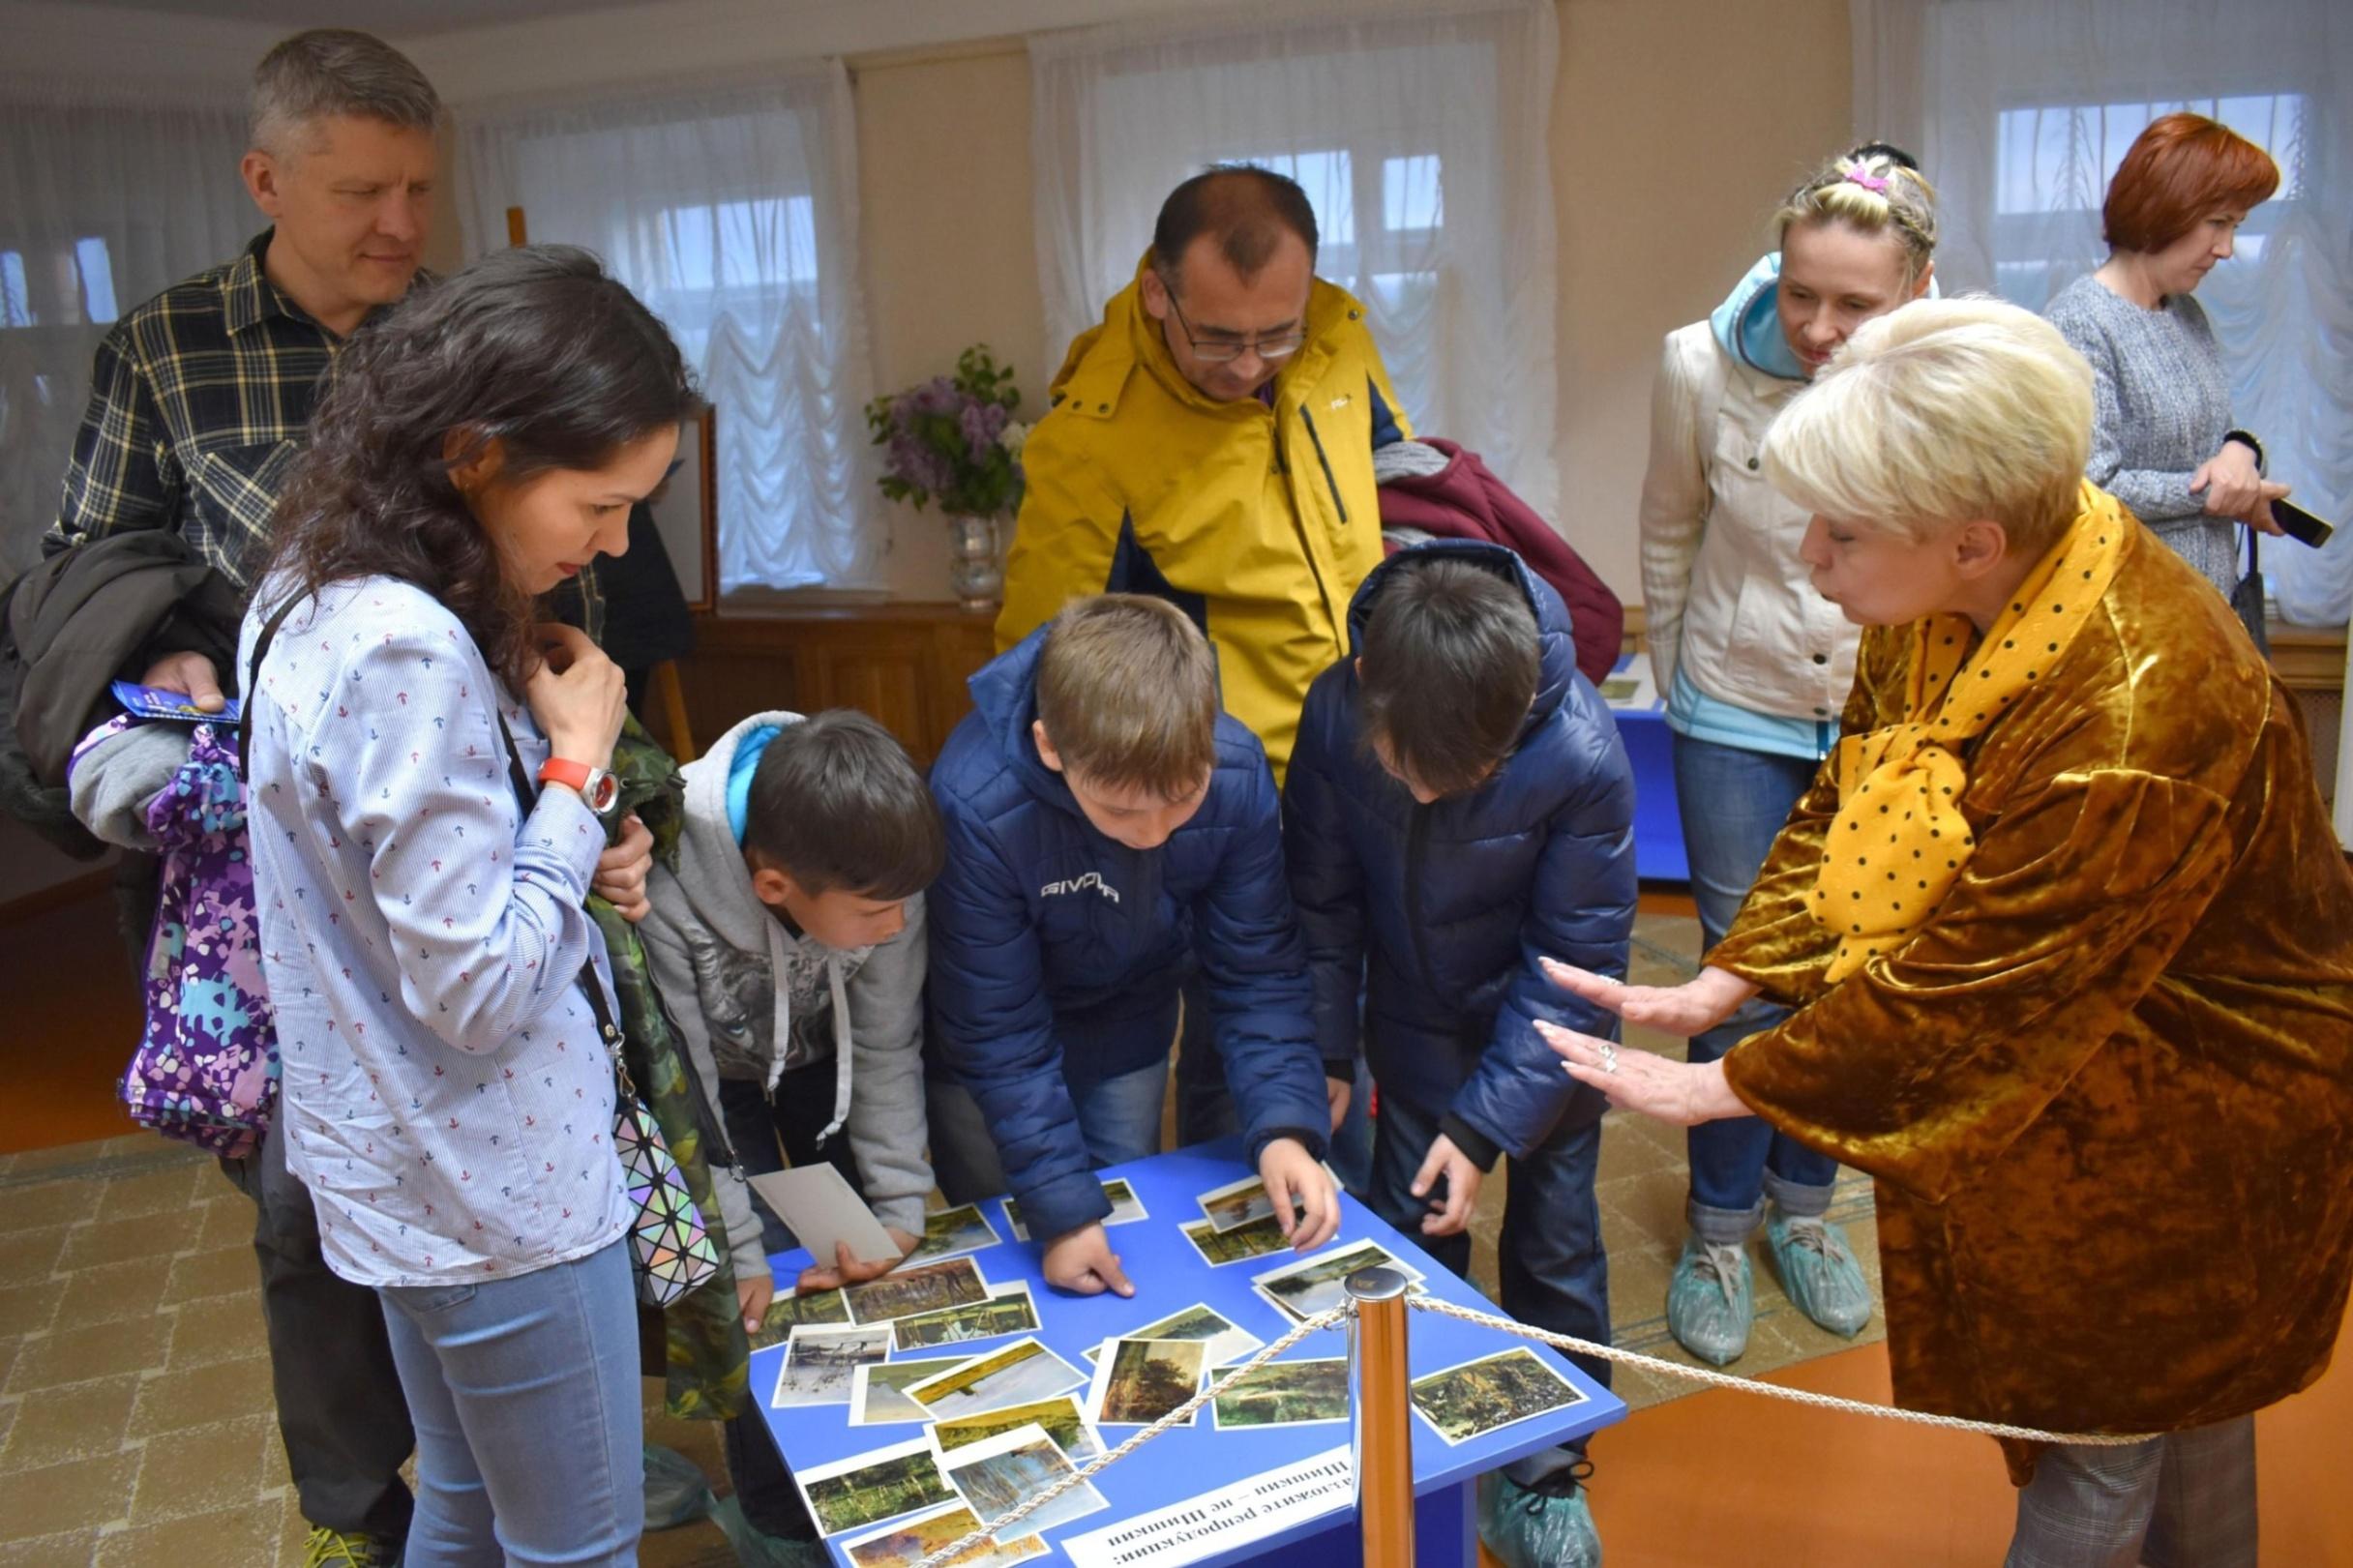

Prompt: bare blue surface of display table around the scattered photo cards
[{"left": 751, "top": 1138, "right": 1626, "bottom": 1568}]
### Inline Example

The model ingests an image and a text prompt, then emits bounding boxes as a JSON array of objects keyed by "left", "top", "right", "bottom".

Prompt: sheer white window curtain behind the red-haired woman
[{"left": 1854, "top": 0, "right": 2353, "bottom": 625}]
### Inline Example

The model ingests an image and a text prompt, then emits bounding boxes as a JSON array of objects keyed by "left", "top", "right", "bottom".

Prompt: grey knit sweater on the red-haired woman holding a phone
[{"left": 2042, "top": 273, "right": 2245, "bottom": 597}]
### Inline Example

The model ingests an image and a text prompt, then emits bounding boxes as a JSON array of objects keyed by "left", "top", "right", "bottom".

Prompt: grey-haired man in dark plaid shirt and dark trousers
[{"left": 43, "top": 28, "right": 607, "bottom": 1568}]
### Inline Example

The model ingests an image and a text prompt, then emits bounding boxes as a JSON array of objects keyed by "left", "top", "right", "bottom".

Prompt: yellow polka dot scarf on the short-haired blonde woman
[{"left": 1814, "top": 485, "right": 2130, "bottom": 983}]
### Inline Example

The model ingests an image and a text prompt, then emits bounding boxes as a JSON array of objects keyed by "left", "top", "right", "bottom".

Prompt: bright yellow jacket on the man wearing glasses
[{"left": 998, "top": 256, "right": 1412, "bottom": 781}]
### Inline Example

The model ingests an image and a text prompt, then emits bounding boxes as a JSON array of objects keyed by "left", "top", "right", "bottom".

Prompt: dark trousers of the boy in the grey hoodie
[{"left": 720, "top": 1058, "right": 866, "bottom": 1540}]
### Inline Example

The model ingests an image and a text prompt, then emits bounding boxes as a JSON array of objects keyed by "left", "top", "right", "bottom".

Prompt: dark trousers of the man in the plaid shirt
[{"left": 222, "top": 1129, "right": 416, "bottom": 1542}]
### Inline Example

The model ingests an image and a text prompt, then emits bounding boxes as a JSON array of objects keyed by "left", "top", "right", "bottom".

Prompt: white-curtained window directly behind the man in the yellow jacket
[{"left": 1030, "top": 0, "right": 1558, "bottom": 515}]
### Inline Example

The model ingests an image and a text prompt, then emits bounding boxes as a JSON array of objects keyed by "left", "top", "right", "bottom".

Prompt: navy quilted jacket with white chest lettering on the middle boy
[{"left": 927, "top": 628, "right": 1329, "bottom": 1241}]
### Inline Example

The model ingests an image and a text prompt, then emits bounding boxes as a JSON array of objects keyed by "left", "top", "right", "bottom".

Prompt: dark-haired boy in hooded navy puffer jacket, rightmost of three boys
[{"left": 1282, "top": 541, "right": 1635, "bottom": 1568}]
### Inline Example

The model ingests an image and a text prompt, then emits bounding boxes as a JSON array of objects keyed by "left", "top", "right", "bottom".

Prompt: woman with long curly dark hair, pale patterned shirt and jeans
[{"left": 240, "top": 247, "right": 699, "bottom": 1568}]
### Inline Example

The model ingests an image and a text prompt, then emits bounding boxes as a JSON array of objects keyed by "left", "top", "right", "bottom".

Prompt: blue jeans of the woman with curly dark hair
[{"left": 376, "top": 1241, "right": 644, "bottom": 1568}]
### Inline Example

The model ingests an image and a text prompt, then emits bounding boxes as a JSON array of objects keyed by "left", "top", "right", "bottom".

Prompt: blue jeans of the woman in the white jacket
[{"left": 1673, "top": 736, "right": 1837, "bottom": 1246}]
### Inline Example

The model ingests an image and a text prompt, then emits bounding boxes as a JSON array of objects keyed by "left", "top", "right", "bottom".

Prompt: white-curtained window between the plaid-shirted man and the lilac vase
[{"left": 463, "top": 66, "right": 884, "bottom": 592}]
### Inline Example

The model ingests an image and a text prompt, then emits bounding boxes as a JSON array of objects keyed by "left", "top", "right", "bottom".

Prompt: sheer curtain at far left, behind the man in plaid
[{"left": 0, "top": 84, "right": 252, "bottom": 580}]
